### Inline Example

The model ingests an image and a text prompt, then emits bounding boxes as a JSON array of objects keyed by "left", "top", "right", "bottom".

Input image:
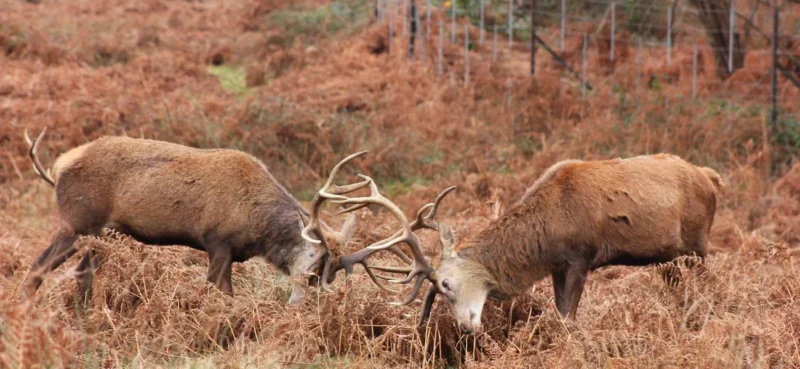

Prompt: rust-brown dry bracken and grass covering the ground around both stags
[{"left": 0, "top": 0, "right": 800, "bottom": 368}]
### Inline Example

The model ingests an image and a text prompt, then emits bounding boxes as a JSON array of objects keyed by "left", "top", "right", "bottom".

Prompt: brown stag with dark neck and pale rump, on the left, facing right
[{"left": 25, "top": 130, "right": 368, "bottom": 304}]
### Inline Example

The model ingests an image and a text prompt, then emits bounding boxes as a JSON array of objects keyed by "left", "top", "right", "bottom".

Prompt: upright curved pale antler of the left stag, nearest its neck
[{"left": 301, "top": 151, "right": 370, "bottom": 292}]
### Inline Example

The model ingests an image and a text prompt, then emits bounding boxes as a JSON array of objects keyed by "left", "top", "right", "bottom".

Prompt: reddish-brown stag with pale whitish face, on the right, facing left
[{"left": 322, "top": 154, "right": 722, "bottom": 334}]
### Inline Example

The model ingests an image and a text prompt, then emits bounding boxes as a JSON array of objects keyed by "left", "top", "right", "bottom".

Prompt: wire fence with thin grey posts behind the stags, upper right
[{"left": 375, "top": 0, "right": 800, "bottom": 134}]
